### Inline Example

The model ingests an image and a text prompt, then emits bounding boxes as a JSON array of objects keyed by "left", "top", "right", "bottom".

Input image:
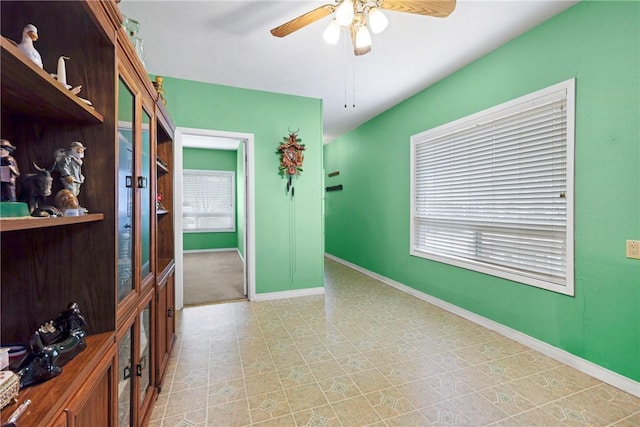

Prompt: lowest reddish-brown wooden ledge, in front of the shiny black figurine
[{"left": 0, "top": 332, "right": 115, "bottom": 426}]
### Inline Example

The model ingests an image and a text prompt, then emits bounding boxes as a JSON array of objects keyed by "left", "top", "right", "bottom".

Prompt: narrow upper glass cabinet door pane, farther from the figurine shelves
[{"left": 138, "top": 109, "right": 155, "bottom": 281}]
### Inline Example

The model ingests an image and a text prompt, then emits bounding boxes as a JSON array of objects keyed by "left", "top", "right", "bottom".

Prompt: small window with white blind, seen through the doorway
[{"left": 182, "top": 169, "right": 236, "bottom": 232}]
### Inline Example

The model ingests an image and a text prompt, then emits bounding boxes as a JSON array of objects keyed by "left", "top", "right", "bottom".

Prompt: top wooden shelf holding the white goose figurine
[{"left": 0, "top": 37, "right": 104, "bottom": 124}]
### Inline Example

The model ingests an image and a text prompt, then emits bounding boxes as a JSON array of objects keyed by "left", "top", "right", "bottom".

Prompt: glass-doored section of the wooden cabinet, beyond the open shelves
[{"left": 116, "top": 19, "right": 175, "bottom": 425}]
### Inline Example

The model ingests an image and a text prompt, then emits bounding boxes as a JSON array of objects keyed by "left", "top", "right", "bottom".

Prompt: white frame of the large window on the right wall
[{"left": 409, "top": 78, "right": 575, "bottom": 296}]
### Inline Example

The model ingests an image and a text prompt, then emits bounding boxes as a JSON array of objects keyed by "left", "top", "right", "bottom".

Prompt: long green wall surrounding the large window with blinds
[{"left": 324, "top": 1, "right": 640, "bottom": 381}]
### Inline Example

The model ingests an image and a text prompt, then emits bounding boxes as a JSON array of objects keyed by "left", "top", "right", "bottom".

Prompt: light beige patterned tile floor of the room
[{"left": 149, "top": 259, "right": 640, "bottom": 427}]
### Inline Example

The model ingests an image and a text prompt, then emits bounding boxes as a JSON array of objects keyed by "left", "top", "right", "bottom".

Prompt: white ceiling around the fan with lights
[{"left": 119, "top": 0, "right": 578, "bottom": 142}]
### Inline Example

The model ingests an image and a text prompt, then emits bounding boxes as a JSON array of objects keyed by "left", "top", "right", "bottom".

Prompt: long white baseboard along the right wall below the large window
[{"left": 325, "top": 253, "right": 640, "bottom": 398}]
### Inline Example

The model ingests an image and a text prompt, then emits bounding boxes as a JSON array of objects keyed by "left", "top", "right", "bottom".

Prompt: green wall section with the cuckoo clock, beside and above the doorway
[{"left": 164, "top": 77, "right": 324, "bottom": 294}]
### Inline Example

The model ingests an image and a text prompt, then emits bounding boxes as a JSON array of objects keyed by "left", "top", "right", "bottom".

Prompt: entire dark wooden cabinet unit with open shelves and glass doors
[{"left": 0, "top": 0, "right": 175, "bottom": 427}]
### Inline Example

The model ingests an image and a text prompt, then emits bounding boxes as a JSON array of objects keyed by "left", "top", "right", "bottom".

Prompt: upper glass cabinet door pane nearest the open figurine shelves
[{"left": 117, "top": 79, "right": 135, "bottom": 302}]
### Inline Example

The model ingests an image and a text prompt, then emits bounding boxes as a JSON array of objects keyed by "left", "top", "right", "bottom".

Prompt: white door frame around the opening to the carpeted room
[{"left": 173, "top": 127, "right": 256, "bottom": 310}]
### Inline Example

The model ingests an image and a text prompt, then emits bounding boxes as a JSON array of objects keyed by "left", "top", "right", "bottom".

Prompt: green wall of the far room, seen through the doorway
[{"left": 182, "top": 148, "right": 238, "bottom": 251}]
